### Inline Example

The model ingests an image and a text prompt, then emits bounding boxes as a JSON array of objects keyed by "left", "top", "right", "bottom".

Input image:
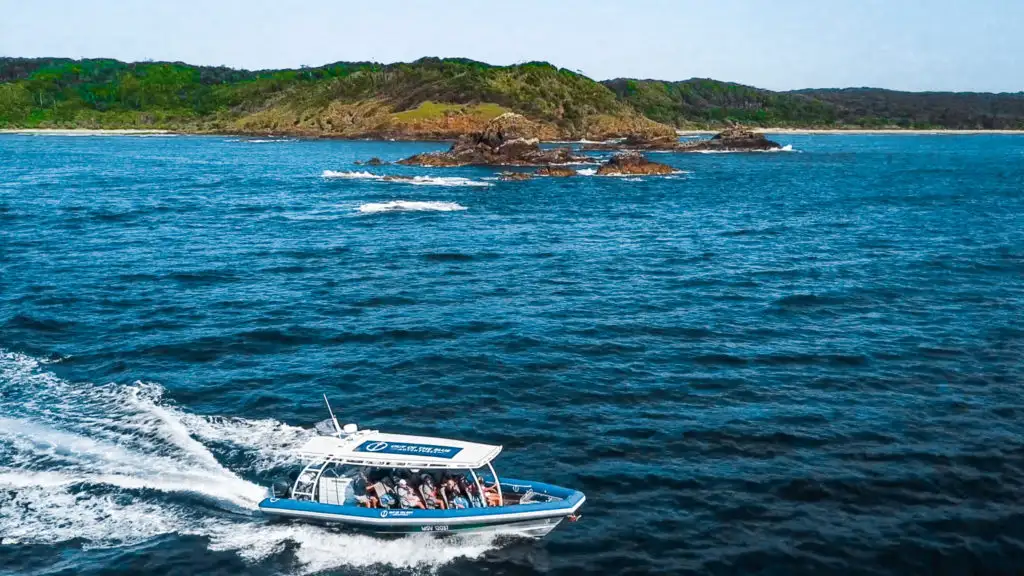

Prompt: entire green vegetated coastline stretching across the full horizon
[{"left": 0, "top": 58, "right": 1024, "bottom": 137}]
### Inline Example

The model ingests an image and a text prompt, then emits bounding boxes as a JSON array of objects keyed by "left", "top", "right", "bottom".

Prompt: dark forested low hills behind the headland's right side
[{"left": 603, "top": 79, "right": 1024, "bottom": 129}]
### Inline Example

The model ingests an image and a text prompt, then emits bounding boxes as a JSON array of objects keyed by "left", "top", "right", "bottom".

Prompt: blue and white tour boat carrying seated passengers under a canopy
[{"left": 259, "top": 396, "right": 587, "bottom": 538}]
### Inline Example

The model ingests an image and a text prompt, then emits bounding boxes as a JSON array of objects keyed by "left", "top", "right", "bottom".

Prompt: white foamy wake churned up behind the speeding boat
[{"left": 0, "top": 351, "right": 495, "bottom": 573}]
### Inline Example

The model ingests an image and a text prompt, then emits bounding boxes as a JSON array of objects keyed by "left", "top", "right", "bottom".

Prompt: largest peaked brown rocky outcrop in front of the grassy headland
[{"left": 398, "top": 112, "right": 588, "bottom": 167}]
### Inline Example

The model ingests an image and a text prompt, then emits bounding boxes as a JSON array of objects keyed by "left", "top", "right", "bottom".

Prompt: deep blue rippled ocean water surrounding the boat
[{"left": 0, "top": 135, "right": 1024, "bottom": 576}]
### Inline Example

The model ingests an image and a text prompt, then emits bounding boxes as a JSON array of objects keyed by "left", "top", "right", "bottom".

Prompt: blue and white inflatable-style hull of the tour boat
[{"left": 259, "top": 479, "right": 587, "bottom": 537}]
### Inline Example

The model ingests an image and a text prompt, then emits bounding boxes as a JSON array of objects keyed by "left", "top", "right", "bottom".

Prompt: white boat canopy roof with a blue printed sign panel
[{"left": 298, "top": 430, "right": 502, "bottom": 469}]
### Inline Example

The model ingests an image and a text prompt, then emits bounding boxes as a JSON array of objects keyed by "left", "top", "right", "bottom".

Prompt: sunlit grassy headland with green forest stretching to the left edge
[{"left": 0, "top": 58, "right": 666, "bottom": 137}]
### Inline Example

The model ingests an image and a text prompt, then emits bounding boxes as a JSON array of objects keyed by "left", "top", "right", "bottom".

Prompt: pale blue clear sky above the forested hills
[{"left": 0, "top": 0, "right": 1024, "bottom": 92}]
